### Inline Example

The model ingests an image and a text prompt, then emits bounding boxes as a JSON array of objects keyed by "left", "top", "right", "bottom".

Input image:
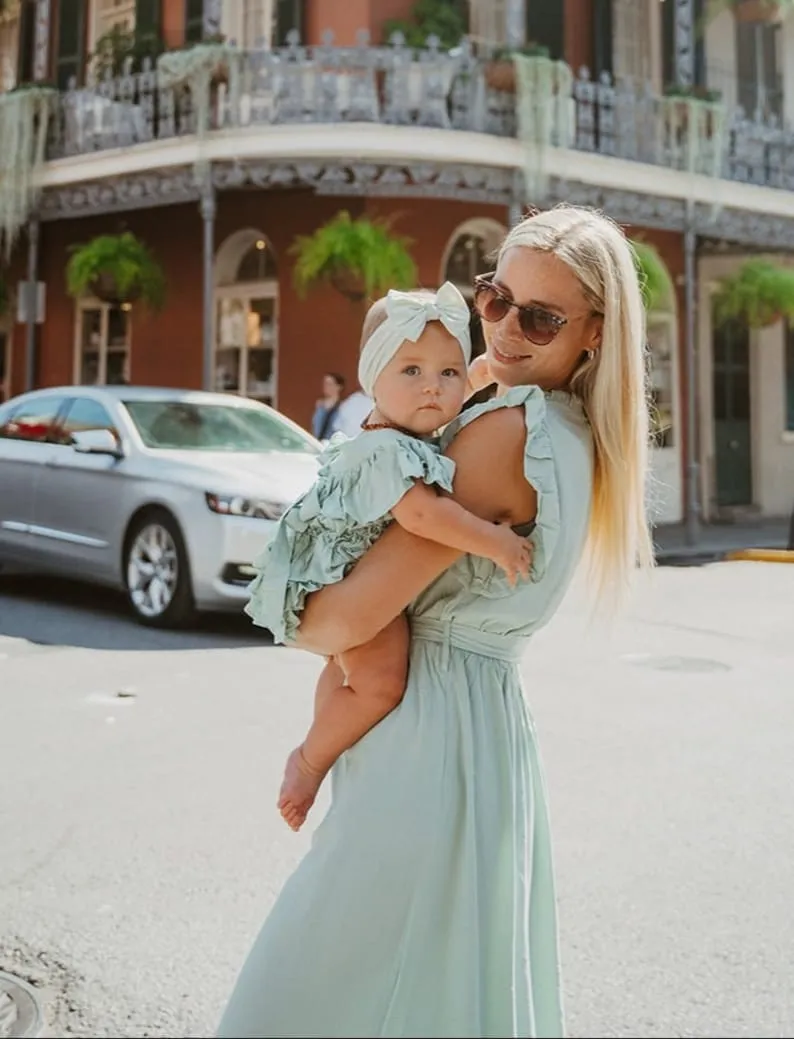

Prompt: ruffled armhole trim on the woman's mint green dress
[{"left": 442, "top": 387, "right": 560, "bottom": 596}]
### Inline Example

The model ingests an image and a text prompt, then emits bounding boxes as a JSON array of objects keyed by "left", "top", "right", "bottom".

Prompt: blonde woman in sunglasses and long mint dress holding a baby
[{"left": 219, "top": 207, "right": 651, "bottom": 1039}]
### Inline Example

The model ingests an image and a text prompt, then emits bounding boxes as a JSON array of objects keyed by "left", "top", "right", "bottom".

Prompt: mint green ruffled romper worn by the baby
[{"left": 245, "top": 429, "right": 455, "bottom": 642}]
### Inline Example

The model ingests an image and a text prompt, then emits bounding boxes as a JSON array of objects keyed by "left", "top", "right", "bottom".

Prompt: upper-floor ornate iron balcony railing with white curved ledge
[{"left": 31, "top": 31, "right": 794, "bottom": 209}]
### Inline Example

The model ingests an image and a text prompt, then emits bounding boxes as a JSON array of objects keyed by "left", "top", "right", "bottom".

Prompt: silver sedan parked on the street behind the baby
[{"left": 0, "top": 387, "right": 320, "bottom": 627}]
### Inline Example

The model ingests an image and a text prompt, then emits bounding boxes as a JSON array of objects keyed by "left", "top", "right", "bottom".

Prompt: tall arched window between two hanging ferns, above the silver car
[{"left": 215, "top": 229, "right": 279, "bottom": 404}]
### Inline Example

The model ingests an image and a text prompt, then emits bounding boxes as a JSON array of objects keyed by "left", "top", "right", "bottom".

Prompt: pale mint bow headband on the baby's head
[{"left": 359, "top": 282, "right": 472, "bottom": 397}]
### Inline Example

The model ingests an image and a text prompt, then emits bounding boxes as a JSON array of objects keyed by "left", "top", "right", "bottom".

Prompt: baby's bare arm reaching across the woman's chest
[{"left": 392, "top": 483, "right": 532, "bottom": 584}]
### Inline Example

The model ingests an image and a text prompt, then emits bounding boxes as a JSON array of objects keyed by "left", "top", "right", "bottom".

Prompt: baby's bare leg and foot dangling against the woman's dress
[{"left": 279, "top": 616, "right": 409, "bottom": 830}]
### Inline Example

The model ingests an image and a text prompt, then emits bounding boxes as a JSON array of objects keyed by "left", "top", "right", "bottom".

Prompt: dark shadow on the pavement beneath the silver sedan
[{"left": 0, "top": 574, "right": 272, "bottom": 650}]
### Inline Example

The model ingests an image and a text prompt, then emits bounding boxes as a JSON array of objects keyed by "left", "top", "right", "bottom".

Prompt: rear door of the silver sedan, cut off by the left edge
[{"left": 0, "top": 394, "right": 65, "bottom": 562}]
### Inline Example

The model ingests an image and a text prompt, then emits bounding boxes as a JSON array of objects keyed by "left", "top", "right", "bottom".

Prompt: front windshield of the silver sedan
[{"left": 124, "top": 400, "right": 317, "bottom": 454}]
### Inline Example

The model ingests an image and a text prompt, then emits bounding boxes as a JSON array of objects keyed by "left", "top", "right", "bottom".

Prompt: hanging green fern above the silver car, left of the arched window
[{"left": 67, "top": 231, "right": 165, "bottom": 310}]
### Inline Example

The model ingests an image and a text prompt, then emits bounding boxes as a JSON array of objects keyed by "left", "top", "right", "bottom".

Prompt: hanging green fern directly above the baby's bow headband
[{"left": 290, "top": 210, "right": 417, "bottom": 302}]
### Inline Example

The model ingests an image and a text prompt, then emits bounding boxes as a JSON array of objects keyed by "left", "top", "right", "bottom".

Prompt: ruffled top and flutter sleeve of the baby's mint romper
[{"left": 298, "top": 429, "right": 455, "bottom": 525}]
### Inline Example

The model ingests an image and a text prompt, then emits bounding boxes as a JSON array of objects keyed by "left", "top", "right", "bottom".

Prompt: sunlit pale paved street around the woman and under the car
[{"left": 0, "top": 563, "right": 794, "bottom": 1039}]
